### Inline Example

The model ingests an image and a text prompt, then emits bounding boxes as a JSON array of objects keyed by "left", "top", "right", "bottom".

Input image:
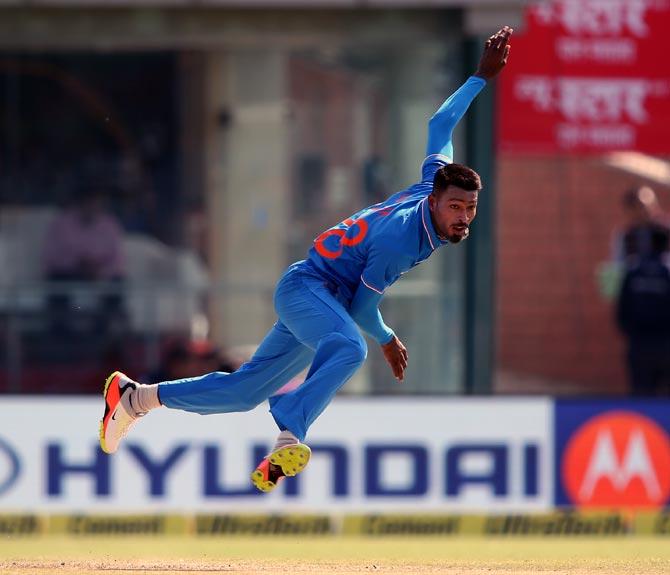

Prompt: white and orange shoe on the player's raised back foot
[{"left": 100, "top": 371, "right": 139, "bottom": 453}]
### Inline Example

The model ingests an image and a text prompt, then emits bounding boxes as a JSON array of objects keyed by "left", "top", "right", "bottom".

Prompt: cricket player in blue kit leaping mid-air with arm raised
[{"left": 100, "top": 26, "right": 512, "bottom": 491}]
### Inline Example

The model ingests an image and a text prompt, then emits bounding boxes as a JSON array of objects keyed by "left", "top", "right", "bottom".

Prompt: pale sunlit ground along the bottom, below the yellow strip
[{"left": 0, "top": 536, "right": 670, "bottom": 575}]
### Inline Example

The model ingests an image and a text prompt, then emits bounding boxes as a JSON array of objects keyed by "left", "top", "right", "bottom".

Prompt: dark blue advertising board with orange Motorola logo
[{"left": 555, "top": 400, "right": 670, "bottom": 509}]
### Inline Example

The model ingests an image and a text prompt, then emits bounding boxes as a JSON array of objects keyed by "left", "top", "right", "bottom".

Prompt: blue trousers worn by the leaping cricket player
[{"left": 158, "top": 261, "right": 367, "bottom": 441}]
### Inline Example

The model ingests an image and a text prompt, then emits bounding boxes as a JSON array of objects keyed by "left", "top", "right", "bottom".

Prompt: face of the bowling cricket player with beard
[{"left": 428, "top": 186, "right": 479, "bottom": 244}]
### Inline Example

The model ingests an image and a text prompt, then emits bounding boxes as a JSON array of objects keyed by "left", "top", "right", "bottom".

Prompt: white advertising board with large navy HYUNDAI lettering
[{"left": 0, "top": 397, "right": 554, "bottom": 516}]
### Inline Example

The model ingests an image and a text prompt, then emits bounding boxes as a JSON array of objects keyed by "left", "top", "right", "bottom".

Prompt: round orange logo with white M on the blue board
[{"left": 561, "top": 411, "right": 670, "bottom": 507}]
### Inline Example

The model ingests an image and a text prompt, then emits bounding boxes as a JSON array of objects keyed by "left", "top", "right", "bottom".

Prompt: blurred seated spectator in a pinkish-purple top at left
[{"left": 44, "top": 186, "right": 125, "bottom": 331}]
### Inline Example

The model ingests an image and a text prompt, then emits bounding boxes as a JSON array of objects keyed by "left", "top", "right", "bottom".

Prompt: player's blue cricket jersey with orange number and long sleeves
[{"left": 305, "top": 76, "right": 486, "bottom": 343}]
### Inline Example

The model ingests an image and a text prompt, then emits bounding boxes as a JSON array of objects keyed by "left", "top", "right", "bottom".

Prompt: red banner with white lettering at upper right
[{"left": 498, "top": 0, "right": 670, "bottom": 154}]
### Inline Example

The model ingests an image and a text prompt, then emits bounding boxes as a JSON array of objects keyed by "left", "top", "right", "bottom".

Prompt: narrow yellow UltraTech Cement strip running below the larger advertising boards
[{"left": 0, "top": 511, "right": 670, "bottom": 538}]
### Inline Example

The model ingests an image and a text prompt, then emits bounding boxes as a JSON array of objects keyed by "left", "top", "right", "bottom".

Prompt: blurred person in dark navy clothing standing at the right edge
[{"left": 617, "top": 226, "right": 670, "bottom": 396}]
